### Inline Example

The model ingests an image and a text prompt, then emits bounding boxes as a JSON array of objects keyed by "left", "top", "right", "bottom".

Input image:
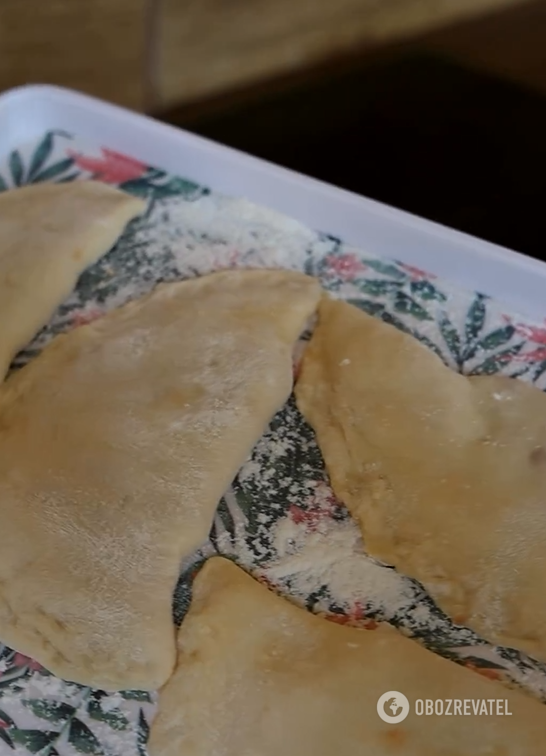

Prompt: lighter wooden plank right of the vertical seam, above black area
[{"left": 156, "top": 0, "right": 523, "bottom": 107}]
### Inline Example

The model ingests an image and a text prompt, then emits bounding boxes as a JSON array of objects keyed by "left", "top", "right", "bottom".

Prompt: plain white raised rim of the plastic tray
[{"left": 0, "top": 85, "right": 546, "bottom": 318}]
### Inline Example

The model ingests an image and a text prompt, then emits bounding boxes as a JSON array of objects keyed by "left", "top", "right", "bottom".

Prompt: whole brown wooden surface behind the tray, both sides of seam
[{"left": 0, "top": 0, "right": 536, "bottom": 111}]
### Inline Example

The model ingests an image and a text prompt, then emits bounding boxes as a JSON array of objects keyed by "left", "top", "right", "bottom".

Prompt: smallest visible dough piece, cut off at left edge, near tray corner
[{"left": 0, "top": 181, "right": 145, "bottom": 380}]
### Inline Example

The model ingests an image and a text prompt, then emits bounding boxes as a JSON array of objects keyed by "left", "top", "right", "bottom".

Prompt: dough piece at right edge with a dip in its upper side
[{"left": 296, "top": 297, "right": 546, "bottom": 659}]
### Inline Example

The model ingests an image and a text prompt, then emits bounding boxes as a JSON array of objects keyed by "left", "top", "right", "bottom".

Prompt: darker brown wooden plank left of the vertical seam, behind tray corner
[{"left": 0, "top": 0, "right": 147, "bottom": 110}]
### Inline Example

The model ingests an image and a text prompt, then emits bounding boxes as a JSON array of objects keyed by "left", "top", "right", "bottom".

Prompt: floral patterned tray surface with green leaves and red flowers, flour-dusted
[{"left": 0, "top": 131, "right": 546, "bottom": 756}]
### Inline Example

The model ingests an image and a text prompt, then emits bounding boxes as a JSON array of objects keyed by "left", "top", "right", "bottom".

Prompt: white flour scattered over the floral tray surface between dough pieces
[{"left": 0, "top": 151, "right": 546, "bottom": 756}]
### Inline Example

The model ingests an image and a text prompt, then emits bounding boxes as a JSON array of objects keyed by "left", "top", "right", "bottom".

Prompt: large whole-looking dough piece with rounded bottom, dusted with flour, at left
[{"left": 0, "top": 270, "right": 320, "bottom": 689}]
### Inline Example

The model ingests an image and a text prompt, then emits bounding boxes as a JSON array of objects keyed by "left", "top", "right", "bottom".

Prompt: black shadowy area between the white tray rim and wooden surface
[{"left": 160, "top": 2, "right": 546, "bottom": 259}]
